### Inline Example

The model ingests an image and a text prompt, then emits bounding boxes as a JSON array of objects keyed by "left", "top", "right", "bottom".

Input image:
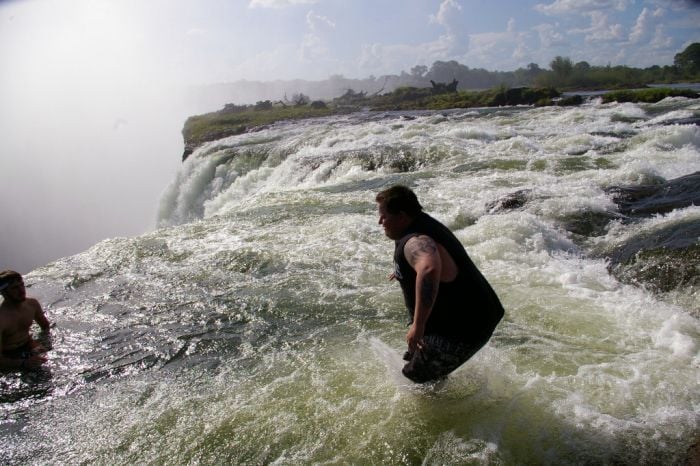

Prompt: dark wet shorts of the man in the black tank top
[{"left": 401, "top": 335, "right": 489, "bottom": 383}]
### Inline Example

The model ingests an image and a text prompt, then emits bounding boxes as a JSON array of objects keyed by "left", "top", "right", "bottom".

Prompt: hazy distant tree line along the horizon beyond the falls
[{"left": 187, "top": 43, "right": 700, "bottom": 110}]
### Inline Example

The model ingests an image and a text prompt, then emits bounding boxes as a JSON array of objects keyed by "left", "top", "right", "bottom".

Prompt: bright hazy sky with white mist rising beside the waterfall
[{"left": 0, "top": 0, "right": 700, "bottom": 273}]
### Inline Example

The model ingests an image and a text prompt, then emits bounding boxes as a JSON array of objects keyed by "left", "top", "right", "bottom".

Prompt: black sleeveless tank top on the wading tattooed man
[{"left": 394, "top": 213, "right": 504, "bottom": 340}]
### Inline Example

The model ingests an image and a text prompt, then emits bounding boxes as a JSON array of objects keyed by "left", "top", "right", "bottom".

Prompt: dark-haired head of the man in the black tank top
[{"left": 376, "top": 185, "right": 423, "bottom": 240}]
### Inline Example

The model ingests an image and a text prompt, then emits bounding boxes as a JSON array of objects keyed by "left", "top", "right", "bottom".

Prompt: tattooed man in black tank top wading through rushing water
[{"left": 376, "top": 186, "right": 504, "bottom": 383}]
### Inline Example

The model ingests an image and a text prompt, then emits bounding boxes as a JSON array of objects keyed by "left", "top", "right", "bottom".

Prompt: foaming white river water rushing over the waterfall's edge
[{"left": 1, "top": 99, "right": 700, "bottom": 464}]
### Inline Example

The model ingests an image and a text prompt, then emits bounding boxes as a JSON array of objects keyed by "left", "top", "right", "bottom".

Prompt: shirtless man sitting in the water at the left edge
[{"left": 0, "top": 270, "right": 50, "bottom": 369}]
